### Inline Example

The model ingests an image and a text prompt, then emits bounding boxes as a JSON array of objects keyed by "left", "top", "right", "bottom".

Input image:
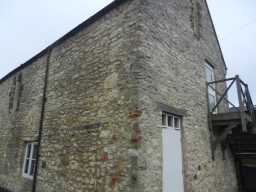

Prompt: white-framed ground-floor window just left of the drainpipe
[{"left": 23, "top": 143, "right": 37, "bottom": 179}]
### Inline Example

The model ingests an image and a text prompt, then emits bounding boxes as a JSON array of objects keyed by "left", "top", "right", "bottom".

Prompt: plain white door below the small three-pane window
[{"left": 162, "top": 114, "right": 184, "bottom": 192}]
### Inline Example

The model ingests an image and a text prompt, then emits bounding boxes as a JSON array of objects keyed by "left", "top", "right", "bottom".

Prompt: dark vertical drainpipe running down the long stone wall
[{"left": 32, "top": 48, "right": 52, "bottom": 192}]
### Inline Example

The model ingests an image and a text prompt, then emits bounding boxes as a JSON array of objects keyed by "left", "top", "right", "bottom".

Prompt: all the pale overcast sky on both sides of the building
[{"left": 0, "top": 0, "right": 256, "bottom": 103}]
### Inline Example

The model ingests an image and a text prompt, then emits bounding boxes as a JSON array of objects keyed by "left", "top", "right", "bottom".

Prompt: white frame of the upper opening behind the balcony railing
[{"left": 205, "top": 61, "right": 218, "bottom": 113}]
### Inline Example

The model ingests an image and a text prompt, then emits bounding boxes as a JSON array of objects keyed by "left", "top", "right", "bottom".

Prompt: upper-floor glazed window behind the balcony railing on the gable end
[{"left": 205, "top": 62, "right": 217, "bottom": 113}]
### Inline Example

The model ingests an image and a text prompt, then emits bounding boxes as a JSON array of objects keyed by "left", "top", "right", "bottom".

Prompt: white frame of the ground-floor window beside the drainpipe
[{"left": 22, "top": 142, "right": 38, "bottom": 179}]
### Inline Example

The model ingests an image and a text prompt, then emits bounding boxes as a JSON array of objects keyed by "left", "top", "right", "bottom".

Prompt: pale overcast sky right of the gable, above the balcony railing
[{"left": 207, "top": 0, "right": 256, "bottom": 104}]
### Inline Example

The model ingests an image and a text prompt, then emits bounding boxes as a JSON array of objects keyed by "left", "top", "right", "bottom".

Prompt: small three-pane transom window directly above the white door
[{"left": 162, "top": 112, "right": 181, "bottom": 129}]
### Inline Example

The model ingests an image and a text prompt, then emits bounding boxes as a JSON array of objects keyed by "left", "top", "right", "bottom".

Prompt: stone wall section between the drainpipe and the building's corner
[{"left": 37, "top": 1, "right": 142, "bottom": 192}]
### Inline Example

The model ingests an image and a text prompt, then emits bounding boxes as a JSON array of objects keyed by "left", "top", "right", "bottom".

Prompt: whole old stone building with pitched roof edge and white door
[{"left": 0, "top": 0, "right": 254, "bottom": 192}]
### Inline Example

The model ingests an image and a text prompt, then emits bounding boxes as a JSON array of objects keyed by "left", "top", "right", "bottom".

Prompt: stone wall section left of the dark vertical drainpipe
[{"left": 0, "top": 57, "right": 46, "bottom": 192}]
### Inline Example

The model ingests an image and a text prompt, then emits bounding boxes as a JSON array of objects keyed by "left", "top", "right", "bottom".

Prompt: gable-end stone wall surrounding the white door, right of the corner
[{"left": 135, "top": 0, "right": 237, "bottom": 192}]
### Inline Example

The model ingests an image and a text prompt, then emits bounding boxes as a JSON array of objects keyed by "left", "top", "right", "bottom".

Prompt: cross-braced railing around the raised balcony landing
[{"left": 207, "top": 75, "right": 256, "bottom": 132}]
